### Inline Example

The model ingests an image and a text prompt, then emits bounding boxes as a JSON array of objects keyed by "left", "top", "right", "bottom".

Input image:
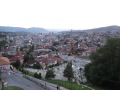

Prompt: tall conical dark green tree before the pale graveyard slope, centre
[{"left": 63, "top": 62, "right": 74, "bottom": 81}]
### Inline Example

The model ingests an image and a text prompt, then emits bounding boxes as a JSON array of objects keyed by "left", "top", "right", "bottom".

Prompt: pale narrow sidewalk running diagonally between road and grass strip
[{"left": 23, "top": 75, "right": 69, "bottom": 90}]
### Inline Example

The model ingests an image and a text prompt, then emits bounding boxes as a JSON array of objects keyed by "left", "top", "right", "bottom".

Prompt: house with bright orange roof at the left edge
[{"left": 0, "top": 57, "right": 10, "bottom": 70}]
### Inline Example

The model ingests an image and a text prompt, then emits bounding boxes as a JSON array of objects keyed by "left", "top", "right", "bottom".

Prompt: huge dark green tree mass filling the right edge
[{"left": 85, "top": 38, "right": 120, "bottom": 90}]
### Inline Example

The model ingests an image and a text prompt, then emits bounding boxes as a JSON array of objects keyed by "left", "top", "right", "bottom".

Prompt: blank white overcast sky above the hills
[{"left": 0, "top": 0, "right": 120, "bottom": 30}]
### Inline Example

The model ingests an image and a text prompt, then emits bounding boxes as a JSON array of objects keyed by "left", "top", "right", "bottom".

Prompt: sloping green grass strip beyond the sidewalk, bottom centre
[{"left": 46, "top": 80, "right": 92, "bottom": 90}]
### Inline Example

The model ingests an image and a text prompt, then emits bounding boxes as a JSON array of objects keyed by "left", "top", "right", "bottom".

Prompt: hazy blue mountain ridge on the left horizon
[{"left": 0, "top": 26, "right": 48, "bottom": 33}]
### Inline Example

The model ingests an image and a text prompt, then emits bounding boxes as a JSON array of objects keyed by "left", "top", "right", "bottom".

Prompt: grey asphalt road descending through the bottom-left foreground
[{"left": 2, "top": 72, "right": 44, "bottom": 90}]
